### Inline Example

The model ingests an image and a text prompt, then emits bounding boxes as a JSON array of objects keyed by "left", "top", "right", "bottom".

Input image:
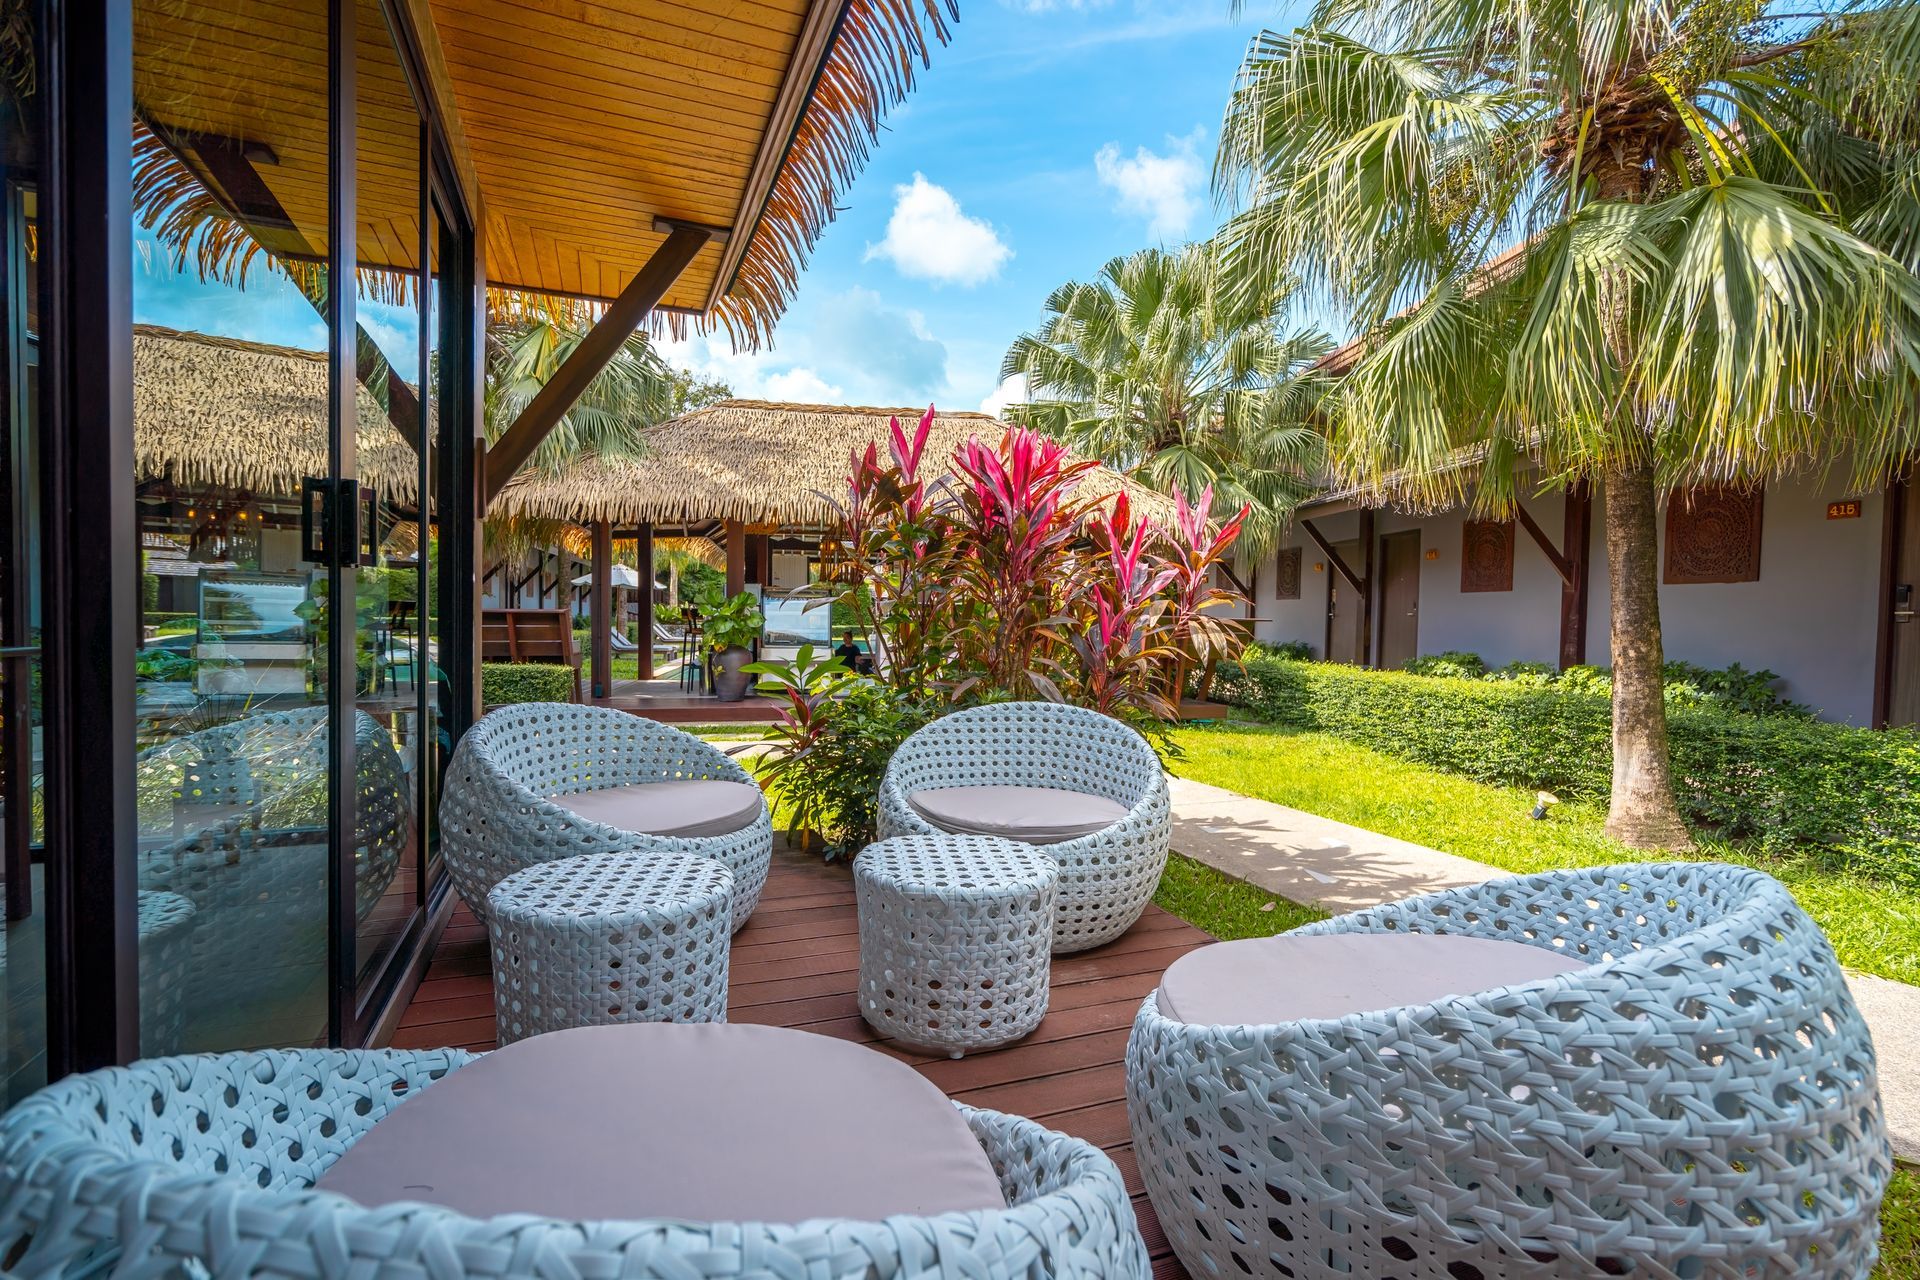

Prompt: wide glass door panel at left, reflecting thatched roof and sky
[{"left": 129, "top": 0, "right": 336, "bottom": 1055}]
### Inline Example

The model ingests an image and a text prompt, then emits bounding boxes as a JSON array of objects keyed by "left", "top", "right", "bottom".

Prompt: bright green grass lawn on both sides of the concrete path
[{"left": 1154, "top": 725, "right": 1920, "bottom": 1280}]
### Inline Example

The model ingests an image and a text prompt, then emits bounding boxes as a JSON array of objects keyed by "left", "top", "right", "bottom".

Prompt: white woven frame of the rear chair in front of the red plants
[{"left": 879, "top": 702, "right": 1173, "bottom": 952}]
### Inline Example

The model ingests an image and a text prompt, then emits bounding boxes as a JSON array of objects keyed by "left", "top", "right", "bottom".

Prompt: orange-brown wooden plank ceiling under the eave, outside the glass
[{"left": 432, "top": 0, "right": 817, "bottom": 309}]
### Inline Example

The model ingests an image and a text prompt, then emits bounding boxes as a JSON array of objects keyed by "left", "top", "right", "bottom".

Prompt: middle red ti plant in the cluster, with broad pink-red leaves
[{"left": 947, "top": 426, "right": 1094, "bottom": 697}]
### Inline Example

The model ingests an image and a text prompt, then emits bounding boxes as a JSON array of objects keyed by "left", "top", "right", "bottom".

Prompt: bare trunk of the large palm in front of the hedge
[{"left": 1601, "top": 459, "right": 1693, "bottom": 850}]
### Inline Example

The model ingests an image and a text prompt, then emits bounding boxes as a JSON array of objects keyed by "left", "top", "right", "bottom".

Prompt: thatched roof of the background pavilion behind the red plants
[{"left": 488, "top": 399, "right": 1173, "bottom": 526}]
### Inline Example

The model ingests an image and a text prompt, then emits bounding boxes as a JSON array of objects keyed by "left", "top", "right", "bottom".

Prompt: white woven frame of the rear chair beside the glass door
[{"left": 440, "top": 702, "right": 774, "bottom": 929}]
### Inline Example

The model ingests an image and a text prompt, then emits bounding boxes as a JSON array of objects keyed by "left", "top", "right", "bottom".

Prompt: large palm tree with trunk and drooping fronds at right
[{"left": 1215, "top": 0, "right": 1920, "bottom": 848}]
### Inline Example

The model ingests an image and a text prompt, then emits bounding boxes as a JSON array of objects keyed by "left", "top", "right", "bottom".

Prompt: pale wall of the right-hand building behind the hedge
[{"left": 1254, "top": 480, "right": 1882, "bottom": 723}]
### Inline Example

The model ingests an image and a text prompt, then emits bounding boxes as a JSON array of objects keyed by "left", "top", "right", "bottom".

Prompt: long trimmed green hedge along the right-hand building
[{"left": 1213, "top": 656, "right": 1920, "bottom": 885}]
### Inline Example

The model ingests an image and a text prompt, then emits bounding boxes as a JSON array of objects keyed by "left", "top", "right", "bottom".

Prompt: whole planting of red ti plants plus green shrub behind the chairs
[{"left": 749, "top": 409, "right": 1246, "bottom": 856}]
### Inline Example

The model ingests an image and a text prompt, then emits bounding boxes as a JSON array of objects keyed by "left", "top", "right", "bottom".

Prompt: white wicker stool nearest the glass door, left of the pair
[{"left": 488, "top": 852, "right": 733, "bottom": 1044}]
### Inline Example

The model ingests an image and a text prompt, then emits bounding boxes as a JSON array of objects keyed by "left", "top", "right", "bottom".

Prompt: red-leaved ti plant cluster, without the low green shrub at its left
[{"left": 822, "top": 409, "right": 1246, "bottom": 718}]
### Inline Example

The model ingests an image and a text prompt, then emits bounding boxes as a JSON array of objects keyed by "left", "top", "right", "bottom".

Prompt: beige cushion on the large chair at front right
[{"left": 1160, "top": 933, "right": 1586, "bottom": 1027}]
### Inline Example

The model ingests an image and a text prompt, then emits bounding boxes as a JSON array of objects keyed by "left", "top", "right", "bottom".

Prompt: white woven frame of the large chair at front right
[{"left": 1127, "top": 862, "right": 1889, "bottom": 1280}]
